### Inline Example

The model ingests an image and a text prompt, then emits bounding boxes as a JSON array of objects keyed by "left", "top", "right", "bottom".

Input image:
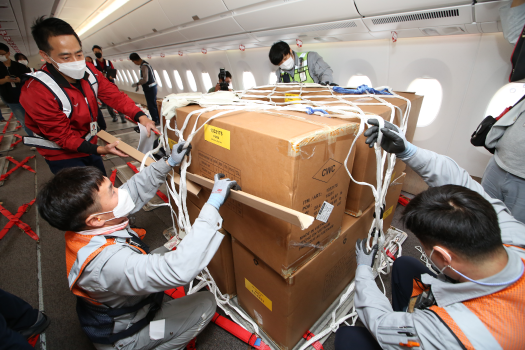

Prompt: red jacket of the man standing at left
[{"left": 20, "top": 63, "right": 145, "bottom": 161}]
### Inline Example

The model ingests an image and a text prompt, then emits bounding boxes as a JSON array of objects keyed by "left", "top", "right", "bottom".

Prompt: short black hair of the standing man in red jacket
[{"left": 31, "top": 16, "right": 82, "bottom": 53}]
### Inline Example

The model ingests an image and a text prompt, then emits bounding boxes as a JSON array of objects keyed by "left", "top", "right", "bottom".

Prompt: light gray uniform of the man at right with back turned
[{"left": 354, "top": 148, "right": 525, "bottom": 350}]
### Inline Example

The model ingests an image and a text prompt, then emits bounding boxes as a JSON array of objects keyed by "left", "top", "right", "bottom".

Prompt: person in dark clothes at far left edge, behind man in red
[{"left": 0, "top": 43, "right": 33, "bottom": 136}]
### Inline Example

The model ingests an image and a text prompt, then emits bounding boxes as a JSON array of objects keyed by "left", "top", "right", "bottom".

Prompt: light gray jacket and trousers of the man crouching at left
[{"left": 72, "top": 161, "right": 224, "bottom": 350}]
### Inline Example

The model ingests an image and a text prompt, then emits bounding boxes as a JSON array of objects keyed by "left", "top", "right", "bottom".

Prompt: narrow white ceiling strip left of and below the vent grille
[{"left": 252, "top": 18, "right": 368, "bottom": 41}]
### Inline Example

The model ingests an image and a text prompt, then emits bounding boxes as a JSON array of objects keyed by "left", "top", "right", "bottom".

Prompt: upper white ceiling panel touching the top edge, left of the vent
[{"left": 232, "top": 0, "right": 360, "bottom": 32}]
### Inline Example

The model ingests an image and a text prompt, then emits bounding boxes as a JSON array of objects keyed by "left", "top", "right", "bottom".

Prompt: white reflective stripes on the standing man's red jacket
[{"left": 23, "top": 67, "right": 98, "bottom": 149}]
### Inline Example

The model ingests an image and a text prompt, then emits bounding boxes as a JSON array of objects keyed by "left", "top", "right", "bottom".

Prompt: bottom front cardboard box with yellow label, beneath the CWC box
[{"left": 233, "top": 206, "right": 374, "bottom": 350}]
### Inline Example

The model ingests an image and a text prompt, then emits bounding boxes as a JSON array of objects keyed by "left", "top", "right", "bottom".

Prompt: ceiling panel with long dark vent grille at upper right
[{"left": 363, "top": 5, "right": 473, "bottom": 32}]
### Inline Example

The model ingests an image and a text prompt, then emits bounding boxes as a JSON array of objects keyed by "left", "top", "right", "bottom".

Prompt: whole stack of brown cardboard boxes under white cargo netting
[{"left": 164, "top": 89, "right": 422, "bottom": 349}]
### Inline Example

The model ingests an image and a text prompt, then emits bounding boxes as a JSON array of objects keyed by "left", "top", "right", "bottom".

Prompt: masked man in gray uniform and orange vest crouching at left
[{"left": 37, "top": 142, "right": 240, "bottom": 350}]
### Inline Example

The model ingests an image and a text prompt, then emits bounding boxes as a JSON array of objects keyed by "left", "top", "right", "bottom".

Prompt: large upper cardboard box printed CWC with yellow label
[{"left": 172, "top": 106, "right": 358, "bottom": 278}]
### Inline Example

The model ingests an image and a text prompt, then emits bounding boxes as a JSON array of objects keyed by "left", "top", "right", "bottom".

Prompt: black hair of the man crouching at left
[{"left": 37, "top": 166, "right": 104, "bottom": 231}]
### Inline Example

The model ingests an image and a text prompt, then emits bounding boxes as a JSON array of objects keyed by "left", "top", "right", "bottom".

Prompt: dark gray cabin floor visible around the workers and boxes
[{"left": 0, "top": 102, "right": 420, "bottom": 350}]
